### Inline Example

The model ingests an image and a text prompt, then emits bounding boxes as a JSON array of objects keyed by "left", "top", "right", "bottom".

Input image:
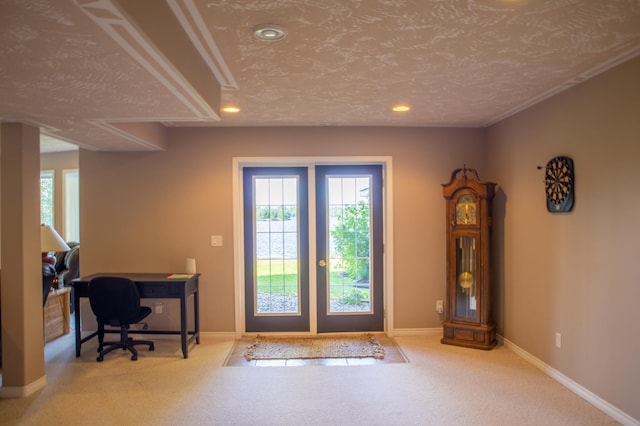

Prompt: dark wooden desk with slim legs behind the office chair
[{"left": 70, "top": 273, "right": 200, "bottom": 358}]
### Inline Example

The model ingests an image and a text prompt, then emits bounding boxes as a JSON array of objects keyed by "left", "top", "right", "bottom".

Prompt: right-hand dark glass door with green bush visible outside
[{"left": 316, "top": 165, "right": 384, "bottom": 333}]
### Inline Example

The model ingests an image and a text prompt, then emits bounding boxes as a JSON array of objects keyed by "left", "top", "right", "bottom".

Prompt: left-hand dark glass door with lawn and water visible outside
[{"left": 243, "top": 167, "right": 309, "bottom": 332}]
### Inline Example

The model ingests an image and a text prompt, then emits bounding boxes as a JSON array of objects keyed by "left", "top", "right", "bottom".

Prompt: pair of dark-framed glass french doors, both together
[{"left": 243, "top": 165, "right": 384, "bottom": 333}]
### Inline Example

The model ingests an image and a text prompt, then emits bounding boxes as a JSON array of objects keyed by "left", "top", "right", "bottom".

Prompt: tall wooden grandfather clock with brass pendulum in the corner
[{"left": 441, "top": 165, "right": 496, "bottom": 350}]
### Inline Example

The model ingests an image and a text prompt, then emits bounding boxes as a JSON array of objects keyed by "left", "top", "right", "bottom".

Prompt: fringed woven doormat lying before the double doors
[{"left": 244, "top": 334, "right": 384, "bottom": 361}]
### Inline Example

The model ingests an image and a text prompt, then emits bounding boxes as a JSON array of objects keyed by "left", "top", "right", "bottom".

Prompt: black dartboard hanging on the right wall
[{"left": 544, "top": 157, "right": 574, "bottom": 213}]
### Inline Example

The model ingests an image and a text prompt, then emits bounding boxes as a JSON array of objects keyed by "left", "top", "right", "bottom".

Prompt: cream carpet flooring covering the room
[{"left": 0, "top": 335, "right": 618, "bottom": 426}]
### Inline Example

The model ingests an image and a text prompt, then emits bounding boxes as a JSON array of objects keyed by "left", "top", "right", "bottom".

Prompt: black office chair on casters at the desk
[{"left": 89, "top": 276, "right": 154, "bottom": 362}]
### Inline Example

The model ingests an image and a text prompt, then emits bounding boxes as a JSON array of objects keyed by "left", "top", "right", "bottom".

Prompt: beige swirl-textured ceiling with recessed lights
[{"left": 0, "top": 0, "right": 640, "bottom": 150}]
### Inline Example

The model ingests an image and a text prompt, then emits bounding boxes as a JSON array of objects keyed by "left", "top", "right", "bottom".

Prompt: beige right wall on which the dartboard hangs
[{"left": 488, "top": 58, "right": 640, "bottom": 419}]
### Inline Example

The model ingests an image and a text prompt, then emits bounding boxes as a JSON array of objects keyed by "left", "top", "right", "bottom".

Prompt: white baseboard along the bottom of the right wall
[{"left": 499, "top": 336, "right": 640, "bottom": 426}]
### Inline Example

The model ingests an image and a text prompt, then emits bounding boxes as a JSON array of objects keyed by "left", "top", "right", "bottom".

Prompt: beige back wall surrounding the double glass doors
[{"left": 80, "top": 128, "right": 484, "bottom": 332}]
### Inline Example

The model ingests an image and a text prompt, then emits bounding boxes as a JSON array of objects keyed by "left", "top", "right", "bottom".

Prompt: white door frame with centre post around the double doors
[{"left": 232, "top": 156, "right": 393, "bottom": 339}]
